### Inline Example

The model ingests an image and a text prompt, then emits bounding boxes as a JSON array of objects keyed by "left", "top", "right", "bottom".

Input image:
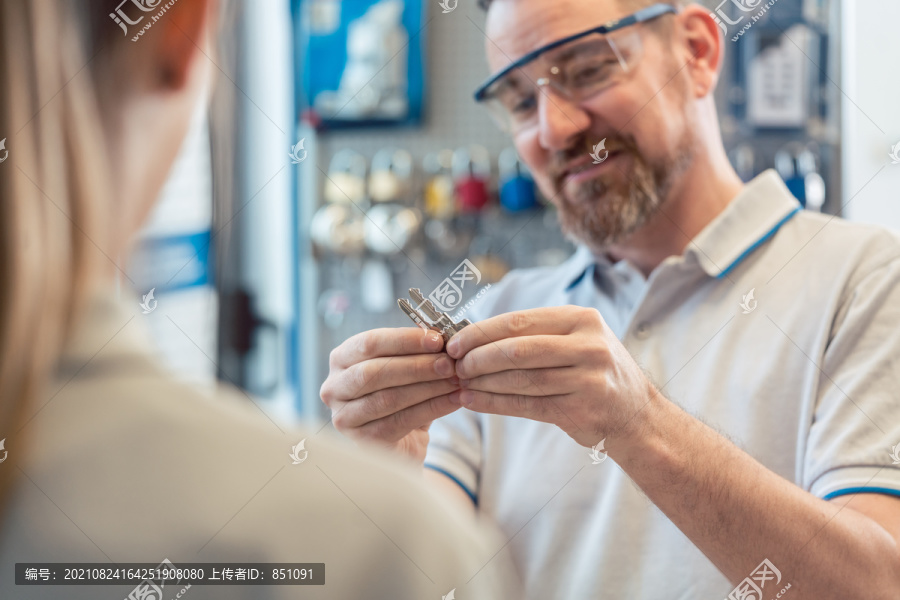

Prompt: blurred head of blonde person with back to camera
[{"left": 0, "top": 0, "right": 215, "bottom": 516}]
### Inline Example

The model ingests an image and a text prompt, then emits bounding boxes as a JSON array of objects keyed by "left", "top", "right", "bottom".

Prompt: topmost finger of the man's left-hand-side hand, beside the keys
[{"left": 330, "top": 327, "right": 444, "bottom": 369}]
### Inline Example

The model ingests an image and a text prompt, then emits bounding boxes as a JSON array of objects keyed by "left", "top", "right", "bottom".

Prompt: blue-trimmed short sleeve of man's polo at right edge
[{"left": 804, "top": 251, "right": 900, "bottom": 499}]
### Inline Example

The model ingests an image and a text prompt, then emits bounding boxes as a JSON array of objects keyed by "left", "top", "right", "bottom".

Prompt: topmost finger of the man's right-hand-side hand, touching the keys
[{"left": 447, "top": 306, "right": 577, "bottom": 358}]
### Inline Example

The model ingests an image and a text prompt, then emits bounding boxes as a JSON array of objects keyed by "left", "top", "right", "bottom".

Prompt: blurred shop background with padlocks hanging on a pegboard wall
[{"left": 123, "top": 0, "right": 900, "bottom": 432}]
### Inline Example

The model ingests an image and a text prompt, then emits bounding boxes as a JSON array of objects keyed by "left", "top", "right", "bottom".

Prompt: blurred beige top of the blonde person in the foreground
[{"left": 0, "top": 292, "right": 517, "bottom": 600}]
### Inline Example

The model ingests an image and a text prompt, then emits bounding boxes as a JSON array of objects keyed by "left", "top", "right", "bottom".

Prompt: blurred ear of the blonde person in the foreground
[{"left": 152, "top": 0, "right": 215, "bottom": 90}]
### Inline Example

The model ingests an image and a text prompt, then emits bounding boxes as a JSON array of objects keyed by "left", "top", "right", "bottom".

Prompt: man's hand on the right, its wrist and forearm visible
[{"left": 447, "top": 306, "right": 656, "bottom": 447}]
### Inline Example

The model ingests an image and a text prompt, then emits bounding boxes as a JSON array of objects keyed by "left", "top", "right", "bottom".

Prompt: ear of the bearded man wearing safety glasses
[{"left": 678, "top": 4, "right": 724, "bottom": 97}]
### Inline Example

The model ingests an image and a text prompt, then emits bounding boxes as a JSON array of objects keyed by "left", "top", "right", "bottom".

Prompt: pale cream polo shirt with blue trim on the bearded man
[{"left": 426, "top": 171, "right": 900, "bottom": 600}]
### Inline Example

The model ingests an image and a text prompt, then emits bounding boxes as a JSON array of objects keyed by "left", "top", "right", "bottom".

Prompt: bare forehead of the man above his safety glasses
[{"left": 485, "top": 0, "right": 627, "bottom": 72}]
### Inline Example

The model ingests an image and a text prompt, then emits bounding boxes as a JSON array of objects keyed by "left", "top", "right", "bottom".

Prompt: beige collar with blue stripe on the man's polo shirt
[{"left": 566, "top": 169, "right": 801, "bottom": 291}]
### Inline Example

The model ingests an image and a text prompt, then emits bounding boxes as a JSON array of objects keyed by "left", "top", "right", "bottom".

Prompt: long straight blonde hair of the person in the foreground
[{"left": 0, "top": 0, "right": 118, "bottom": 509}]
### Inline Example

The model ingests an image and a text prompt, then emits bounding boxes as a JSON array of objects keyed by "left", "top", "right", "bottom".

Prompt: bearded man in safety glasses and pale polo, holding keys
[{"left": 322, "top": 0, "right": 900, "bottom": 600}]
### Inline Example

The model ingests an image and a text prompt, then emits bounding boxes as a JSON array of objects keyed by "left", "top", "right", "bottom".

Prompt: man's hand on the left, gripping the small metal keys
[{"left": 320, "top": 327, "right": 459, "bottom": 463}]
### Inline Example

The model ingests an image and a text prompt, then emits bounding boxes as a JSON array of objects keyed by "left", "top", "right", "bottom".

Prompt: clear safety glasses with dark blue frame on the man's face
[{"left": 475, "top": 4, "right": 677, "bottom": 134}]
